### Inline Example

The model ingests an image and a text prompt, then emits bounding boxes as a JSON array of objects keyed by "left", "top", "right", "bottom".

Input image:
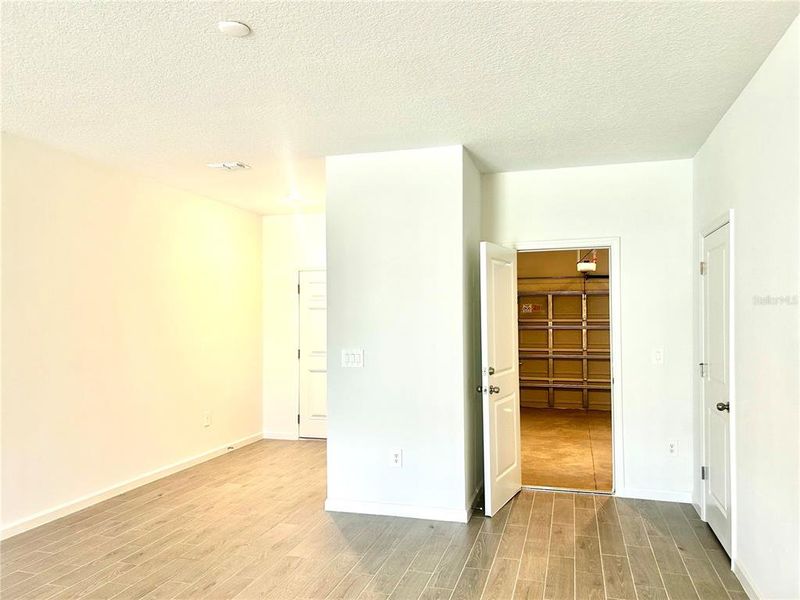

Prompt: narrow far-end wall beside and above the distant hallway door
[{"left": 262, "top": 214, "right": 325, "bottom": 439}]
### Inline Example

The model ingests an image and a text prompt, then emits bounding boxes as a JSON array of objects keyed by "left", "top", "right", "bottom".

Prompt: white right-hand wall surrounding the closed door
[{"left": 694, "top": 15, "right": 800, "bottom": 598}]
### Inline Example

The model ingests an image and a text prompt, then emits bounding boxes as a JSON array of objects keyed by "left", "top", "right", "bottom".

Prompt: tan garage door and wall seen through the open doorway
[{"left": 517, "top": 249, "right": 611, "bottom": 410}]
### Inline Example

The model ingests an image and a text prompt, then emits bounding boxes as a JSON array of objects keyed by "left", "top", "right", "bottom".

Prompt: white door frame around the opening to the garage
[{"left": 502, "top": 237, "right": 625, "bottom": 495}]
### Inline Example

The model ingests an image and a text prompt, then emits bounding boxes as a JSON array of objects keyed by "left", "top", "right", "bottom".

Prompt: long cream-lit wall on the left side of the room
[{"left": 2, "top": 134, "right": 261, "bottom": 534}]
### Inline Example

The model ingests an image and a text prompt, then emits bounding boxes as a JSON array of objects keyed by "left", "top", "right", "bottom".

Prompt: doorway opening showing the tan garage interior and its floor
[{"left": 517, "top": 247, "right": 614, "bottom": 493}]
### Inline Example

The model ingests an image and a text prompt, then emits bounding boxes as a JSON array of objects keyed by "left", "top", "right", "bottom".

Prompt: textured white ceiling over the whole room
[{"left": 2, "top": 1, "right": 798, "bottom": 212}]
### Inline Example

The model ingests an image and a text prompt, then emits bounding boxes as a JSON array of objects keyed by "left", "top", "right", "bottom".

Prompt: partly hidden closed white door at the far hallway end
[{"left": 298, "top": 271, "right": 328, "bottom": 438}]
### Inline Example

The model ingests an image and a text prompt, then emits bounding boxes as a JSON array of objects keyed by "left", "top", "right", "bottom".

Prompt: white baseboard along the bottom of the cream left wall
[{"left": 0, "top": 433, "right": 262, "bottom": 539}]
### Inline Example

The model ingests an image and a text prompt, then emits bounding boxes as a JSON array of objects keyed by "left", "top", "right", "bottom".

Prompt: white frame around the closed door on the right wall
[{"left": 693, "top": 208, "right": 738, "bottom": 569}]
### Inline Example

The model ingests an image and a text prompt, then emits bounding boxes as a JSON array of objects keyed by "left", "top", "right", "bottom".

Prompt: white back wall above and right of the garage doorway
[{"left": 483, "top": 160, "right": 693, "bottom": 501}]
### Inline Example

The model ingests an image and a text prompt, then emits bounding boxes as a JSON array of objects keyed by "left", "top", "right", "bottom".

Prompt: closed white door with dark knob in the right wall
[{"left": 701, "top": 225, "right": 731, "bottom": 554}]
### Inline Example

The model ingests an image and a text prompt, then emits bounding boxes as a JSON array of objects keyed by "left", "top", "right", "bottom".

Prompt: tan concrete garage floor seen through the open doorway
[{"left": 520, "top": 408, "right": 612, "bottom": 492}]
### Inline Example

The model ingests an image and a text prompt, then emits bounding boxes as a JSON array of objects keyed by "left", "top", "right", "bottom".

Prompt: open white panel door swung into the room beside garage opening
[{"left": 481, "top": 242, "right": 522, "bottom": 517}]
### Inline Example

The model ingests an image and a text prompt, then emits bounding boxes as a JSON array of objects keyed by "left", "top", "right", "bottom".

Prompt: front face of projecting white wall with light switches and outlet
[{"left": 326, "top": 146, "right": 471, "bottom": 520}]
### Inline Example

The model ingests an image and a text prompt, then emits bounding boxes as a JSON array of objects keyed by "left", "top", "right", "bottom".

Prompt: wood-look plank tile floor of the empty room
[{"left": 0, "top": 441, "right": 746, "bottom": 600}]
